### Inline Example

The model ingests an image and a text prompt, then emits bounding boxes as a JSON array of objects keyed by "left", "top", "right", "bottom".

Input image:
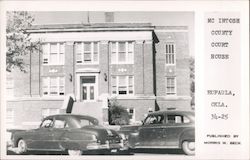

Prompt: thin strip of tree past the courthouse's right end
[{"left": 189, "top": 57, "right": 195, "bottom": 106}]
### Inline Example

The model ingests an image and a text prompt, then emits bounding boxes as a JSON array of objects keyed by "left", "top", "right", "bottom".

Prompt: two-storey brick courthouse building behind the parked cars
[{"left": 6, "top": 14, "right": 191, "bottom": 128}]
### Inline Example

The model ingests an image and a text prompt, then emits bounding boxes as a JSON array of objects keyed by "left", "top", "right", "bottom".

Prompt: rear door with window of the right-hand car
[{"left": 165, "top": 114, "right": 190, "bottom": 148}]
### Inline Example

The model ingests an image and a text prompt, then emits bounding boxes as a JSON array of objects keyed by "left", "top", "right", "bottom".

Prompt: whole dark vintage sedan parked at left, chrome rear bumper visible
[{"left": 11, "top": 114, "right": 126, "bottom": 155}]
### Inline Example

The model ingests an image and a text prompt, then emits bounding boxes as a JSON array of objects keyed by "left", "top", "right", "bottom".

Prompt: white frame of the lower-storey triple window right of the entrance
[{"left": 111, "top": 75, "right": 135, "bottom": 96}]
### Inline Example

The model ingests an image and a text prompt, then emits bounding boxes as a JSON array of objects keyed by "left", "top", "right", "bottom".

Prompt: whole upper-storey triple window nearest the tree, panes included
[{"left": 43, "top": 43, "right": 65, "bottom": 65}]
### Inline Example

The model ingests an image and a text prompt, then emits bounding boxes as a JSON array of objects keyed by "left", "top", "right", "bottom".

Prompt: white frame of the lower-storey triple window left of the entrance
[{"left": 42, "top": 76, "right": 65, "bottom": 97}]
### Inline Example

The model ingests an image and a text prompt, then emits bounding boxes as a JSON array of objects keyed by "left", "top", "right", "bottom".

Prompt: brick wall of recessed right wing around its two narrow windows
[{"left": 155, "top": 31, "right": 191, "bottom": 109}]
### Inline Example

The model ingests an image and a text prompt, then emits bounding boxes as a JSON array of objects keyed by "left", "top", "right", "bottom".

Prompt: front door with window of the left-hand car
[{"left": 28, "top": 118, "right": 54, "bottom": 150}]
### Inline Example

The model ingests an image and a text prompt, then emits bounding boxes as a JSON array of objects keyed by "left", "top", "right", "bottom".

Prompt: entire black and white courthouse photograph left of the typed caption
[{"left": 6, "top": 11, "right": 195, "bottom": 158}]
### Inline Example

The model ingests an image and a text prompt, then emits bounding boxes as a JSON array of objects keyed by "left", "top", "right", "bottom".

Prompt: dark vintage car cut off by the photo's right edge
[{"left": 119, "top": 110, "right": 195, "bottom": 155}]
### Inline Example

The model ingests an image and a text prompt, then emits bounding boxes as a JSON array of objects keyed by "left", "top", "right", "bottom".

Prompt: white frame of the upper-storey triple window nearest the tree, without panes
[{"left": 42, "top": 42, "right": 65, "bottom": 65}]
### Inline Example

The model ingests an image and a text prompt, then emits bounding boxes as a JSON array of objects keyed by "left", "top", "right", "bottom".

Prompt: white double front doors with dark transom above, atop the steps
[{"left": 80, "top": 76, "right": 97, "bottom": 101}]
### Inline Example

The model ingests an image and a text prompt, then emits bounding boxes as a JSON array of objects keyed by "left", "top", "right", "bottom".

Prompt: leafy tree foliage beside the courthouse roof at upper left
[{"left": 6, "top": 11, "right": 40, "bottom": 72}]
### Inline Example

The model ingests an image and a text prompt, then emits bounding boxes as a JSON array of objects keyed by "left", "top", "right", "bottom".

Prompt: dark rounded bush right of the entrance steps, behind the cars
[{"left": 108, "top": 99, "right": 129, "bottom": 125}]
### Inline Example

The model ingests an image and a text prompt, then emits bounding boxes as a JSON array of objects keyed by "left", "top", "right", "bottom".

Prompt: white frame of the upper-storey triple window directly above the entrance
[{"left": 74, "top": 41, "right": 100, "bottom": 65}]
